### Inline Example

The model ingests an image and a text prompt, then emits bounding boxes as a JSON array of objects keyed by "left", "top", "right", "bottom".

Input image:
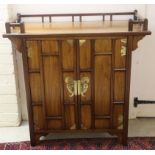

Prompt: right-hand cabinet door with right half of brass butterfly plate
[{"left": 77, "top": 38, "right": 126, "bottom": 129}]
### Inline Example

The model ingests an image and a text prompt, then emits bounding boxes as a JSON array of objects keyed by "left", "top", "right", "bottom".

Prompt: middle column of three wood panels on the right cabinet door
[{"left": 94, "top": 39, "right": 113, "bottom": 129}]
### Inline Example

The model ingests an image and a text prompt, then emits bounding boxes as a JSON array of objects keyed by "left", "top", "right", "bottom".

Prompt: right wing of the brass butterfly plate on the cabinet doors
[{"left": 80, "top": 77, "right": 90, "bottom": 97}]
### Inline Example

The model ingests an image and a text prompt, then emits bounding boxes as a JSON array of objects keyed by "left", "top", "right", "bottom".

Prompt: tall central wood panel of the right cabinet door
[{"left": 95, "top": 56, "right": 111, "bottom": 115}]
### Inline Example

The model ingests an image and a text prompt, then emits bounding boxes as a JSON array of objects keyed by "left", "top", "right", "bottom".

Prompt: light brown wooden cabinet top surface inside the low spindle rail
[{"left": 12, "top": 21, "right": 142, "bottom": 34}]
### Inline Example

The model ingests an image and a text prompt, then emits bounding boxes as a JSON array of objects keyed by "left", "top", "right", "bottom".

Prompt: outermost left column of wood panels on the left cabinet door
[{"left": 26, "top": 41, "right": 45, "bottom": 131}]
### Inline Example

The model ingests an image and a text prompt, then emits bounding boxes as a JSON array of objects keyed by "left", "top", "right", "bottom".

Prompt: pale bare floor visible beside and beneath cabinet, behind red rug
[{"left": 0, "top": 118, "right": 155, "bottom": 143}]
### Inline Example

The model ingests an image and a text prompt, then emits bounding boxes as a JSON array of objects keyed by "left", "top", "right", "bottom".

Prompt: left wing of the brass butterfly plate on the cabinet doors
[{"left": 65, "top": 77, "right": 76, "bottom": 97}]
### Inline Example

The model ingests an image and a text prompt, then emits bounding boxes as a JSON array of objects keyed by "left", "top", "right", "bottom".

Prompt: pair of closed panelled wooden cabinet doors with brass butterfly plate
[{"left": 26, "top": 38, "right": 127, "bottom": 131}]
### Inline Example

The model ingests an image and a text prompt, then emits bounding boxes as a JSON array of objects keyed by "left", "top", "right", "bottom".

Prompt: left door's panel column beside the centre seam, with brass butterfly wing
[{"left": 61, "top": 40, "right": 77, "bottom": 130}]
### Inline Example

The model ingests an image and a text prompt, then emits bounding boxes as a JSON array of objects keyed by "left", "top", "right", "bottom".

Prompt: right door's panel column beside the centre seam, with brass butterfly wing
[{"left": 77, "top": 40, "right": 92, "bottom": 129}]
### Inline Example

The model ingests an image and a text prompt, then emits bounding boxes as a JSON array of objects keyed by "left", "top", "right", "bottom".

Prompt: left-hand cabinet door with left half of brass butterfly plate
[{"left": 27, "top": 40, "right": 77, "bottom": 130}]
